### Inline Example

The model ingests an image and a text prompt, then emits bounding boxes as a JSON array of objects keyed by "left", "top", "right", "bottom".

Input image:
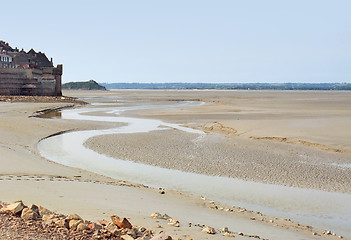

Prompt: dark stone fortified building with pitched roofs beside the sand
[{"left": 0, "top": 41, "right": 63, "bottom": 96}]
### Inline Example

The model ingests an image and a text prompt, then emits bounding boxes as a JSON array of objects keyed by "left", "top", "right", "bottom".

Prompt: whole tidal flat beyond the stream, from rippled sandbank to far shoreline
[{"left": 85, "top": 91, "right": 351, "bottom": 193}]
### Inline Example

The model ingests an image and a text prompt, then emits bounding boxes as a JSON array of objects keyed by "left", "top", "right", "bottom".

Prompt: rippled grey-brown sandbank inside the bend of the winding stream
[{"left": 85, "top": 130, "right": 351, "bottom": 193}]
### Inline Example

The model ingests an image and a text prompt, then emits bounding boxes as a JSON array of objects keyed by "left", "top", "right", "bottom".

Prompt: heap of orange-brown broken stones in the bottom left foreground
[{"left": 0, "top": 201, "right": 173, "bottom": 240}]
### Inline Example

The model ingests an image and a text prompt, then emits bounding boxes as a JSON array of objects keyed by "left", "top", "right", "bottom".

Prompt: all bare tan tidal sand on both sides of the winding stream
[{"left": 0, "top": 90, "right": 351, "bottom": 239}]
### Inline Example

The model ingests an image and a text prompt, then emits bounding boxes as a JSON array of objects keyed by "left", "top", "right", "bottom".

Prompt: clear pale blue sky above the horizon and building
[{"left": 0, "top": 0, "right": 351, "bottom": 83}]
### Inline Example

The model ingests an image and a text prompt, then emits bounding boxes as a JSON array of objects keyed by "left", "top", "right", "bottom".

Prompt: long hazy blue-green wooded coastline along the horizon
[{"left": 100, "top": 83, "right": 351, "bottom": 90}]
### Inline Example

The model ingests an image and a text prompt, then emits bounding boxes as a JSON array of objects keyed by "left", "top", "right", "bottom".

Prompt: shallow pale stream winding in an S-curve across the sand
[{"left": 38, "top": 102, "right": 351, "bottom": 237}]
